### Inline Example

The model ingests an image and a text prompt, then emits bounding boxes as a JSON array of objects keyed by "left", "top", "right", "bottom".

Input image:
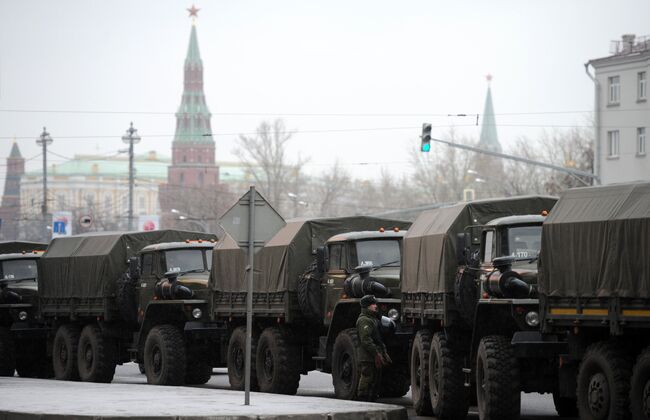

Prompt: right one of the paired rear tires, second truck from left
[{"left": 77, "top": 324, "right": 116, "bottom": 383}]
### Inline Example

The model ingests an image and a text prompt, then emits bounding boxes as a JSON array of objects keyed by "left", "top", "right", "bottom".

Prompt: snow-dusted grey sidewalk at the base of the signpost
[{"left": 0, "top": 377, "right": 407, "bottom": 420}]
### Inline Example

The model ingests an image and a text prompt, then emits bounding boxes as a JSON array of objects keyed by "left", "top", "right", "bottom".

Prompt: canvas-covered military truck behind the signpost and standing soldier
[{"left": 210, "top": 216, "right": 410, "bottom": 399}]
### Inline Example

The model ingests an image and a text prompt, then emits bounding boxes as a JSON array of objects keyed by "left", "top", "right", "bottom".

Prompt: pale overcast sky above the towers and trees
[{"left": 0, "top": 0, "right": 650, "bottom": 181}]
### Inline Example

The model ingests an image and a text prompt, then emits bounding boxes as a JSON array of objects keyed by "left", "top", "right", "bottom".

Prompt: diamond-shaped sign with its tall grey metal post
[{"left": 219, "top": 185, "right": 286, "bottom": 405}]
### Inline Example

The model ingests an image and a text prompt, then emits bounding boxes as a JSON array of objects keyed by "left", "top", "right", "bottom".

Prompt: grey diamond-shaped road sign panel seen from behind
[{"left": 219, "top": 190, "right": 286, "bottom": 250}]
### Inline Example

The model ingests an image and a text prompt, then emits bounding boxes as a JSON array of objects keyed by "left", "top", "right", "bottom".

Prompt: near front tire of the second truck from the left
[{"left": 144, "top": 324, "right": 186, "bottom": 385}]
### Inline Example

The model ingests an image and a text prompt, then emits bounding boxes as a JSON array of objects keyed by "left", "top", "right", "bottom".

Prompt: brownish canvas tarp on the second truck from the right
[{"left": 401, "top": 196, "right": 557, "bottom": 293}]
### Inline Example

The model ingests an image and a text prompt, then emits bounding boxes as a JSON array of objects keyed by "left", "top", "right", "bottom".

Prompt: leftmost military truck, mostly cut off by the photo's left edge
[{"left": 0, "top": 241, "right": 52, "bottom": 378}]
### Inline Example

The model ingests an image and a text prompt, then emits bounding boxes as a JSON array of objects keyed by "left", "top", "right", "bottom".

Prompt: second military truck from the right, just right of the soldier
[{"left": 401, "top": 196, "right": 556, "bottom": 419}]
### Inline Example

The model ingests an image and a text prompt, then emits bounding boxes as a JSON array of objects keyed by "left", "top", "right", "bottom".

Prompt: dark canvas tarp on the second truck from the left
[{"left": 39, "top": 230, "right": 217, "bottom": 298}]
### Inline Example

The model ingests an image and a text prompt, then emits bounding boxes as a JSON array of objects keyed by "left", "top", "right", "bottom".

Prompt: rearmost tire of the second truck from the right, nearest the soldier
[{"left": 411, "top": 330, "right": 433, "bottom": 416}]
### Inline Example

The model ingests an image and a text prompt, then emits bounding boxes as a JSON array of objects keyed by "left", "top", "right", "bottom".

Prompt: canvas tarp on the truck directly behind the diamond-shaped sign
[{"left": 210, "top": 216, "right": 410, "bottom": 292}]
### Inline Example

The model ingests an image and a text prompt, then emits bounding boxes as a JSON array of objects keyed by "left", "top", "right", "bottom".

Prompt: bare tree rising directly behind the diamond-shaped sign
[{"left": 234, "top": 119, "right": 309, "bottom": 213}]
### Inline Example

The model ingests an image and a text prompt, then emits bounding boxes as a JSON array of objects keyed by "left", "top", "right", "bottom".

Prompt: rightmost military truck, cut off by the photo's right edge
[{"left": 536, "top": 182, "right": 650, "bottom": 420}]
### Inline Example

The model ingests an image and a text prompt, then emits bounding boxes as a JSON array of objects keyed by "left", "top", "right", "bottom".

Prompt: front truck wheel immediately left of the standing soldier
[{"left": 332, "top": 328, "right": 361, "bottom": 400}]
